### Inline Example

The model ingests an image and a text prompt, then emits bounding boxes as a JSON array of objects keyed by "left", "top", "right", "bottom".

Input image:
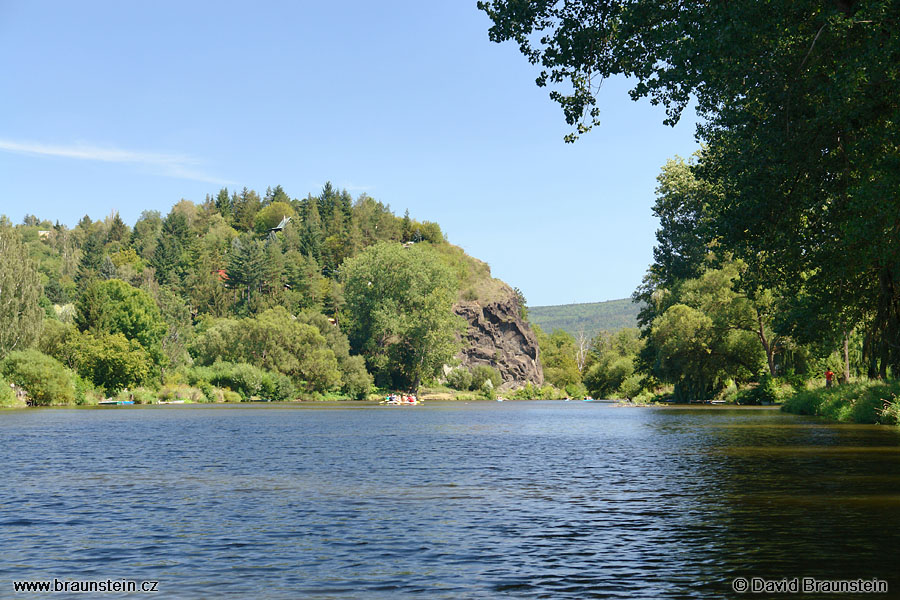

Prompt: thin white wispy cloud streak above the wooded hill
[{"left": 0, "top": 139, "right": 234, "bottom": 185}]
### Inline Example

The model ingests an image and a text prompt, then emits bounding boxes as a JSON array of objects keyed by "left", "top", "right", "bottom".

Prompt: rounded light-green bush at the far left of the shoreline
[{"left": 0, "top": 350, "right": 75, "bottom": 406}]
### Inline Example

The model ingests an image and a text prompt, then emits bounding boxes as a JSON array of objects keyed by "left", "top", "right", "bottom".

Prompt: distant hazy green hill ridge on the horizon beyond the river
[{"left": 528, "top": 298, "right": 641, "bottom": 337}]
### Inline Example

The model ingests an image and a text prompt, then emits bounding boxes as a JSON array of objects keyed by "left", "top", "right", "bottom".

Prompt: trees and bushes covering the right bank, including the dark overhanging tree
[{"left": 478, "top": 0, "right": 900, "bottom": 423}]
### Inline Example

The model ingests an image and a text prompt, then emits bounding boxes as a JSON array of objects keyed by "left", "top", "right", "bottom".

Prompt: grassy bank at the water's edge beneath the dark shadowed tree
[{"left": 782, "top": 381, "right": 900, "bottom": 425}]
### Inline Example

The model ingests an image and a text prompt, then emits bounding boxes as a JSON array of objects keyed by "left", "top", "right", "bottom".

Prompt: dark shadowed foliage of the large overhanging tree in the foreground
[{"left": 479, "top": 0, "right": 900, "bottom": 376}]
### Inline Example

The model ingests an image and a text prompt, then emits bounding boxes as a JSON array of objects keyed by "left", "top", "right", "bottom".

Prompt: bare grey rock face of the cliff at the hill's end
[{"left": 453, "top": 290, "right": 544, "bottom": 389}]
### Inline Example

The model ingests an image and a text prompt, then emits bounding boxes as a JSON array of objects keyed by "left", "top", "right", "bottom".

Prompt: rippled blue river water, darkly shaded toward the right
[{"left": 0, "top": 402, "right": 900, "bottom": 599}]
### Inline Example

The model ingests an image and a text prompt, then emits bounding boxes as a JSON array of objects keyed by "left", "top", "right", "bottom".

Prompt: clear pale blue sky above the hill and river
[{"left": 0, "top": 0, "right": 697, "bottom": 306}]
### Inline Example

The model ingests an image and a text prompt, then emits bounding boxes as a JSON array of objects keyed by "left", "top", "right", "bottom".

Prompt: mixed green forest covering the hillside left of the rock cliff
[{"left": 0, "top": 184, "right": 490, "bottom": 405}]
